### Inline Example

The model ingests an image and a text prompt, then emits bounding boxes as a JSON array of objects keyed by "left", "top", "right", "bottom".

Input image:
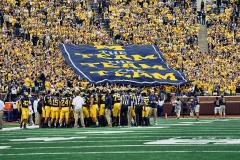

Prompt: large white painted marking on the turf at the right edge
[{"left": 144, "top": 137, "right": 240, "bottom": 145}]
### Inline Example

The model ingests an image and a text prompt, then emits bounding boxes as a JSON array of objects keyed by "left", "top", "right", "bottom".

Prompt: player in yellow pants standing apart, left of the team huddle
[{"left": 19, "top": 92, "right": 32, "bottom": 129}]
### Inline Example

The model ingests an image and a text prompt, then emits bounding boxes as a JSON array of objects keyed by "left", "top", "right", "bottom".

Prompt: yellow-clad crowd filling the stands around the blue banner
[{"left": 0, "top": 0, "right": 240, "bottom": 100}]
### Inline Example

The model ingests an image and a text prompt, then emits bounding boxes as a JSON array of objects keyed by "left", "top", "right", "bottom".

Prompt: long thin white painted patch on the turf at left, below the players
[{"left": 10, "top": 137, "right": 87, "bottom": 142}]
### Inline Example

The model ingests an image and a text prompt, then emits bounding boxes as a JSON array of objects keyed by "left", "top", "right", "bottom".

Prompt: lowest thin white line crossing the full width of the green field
[{"left": 0, "top": 150, "right": 240, "bottom": 156}]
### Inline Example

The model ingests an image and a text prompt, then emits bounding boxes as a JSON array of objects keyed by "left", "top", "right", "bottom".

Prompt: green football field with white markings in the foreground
[{"left": 0, "top": 119, "right": 240, "bottom": 160}]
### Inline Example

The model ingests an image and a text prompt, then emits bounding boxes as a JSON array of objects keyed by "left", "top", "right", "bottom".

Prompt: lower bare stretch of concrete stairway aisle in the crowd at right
[{"left": 198, "top": 25, "right": 208, "bottom": 53}]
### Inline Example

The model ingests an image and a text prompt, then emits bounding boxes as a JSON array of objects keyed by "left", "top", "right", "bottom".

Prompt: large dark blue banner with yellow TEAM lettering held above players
[{"left": 59, "top": 44, "right": 187, "bottom": 85}]
